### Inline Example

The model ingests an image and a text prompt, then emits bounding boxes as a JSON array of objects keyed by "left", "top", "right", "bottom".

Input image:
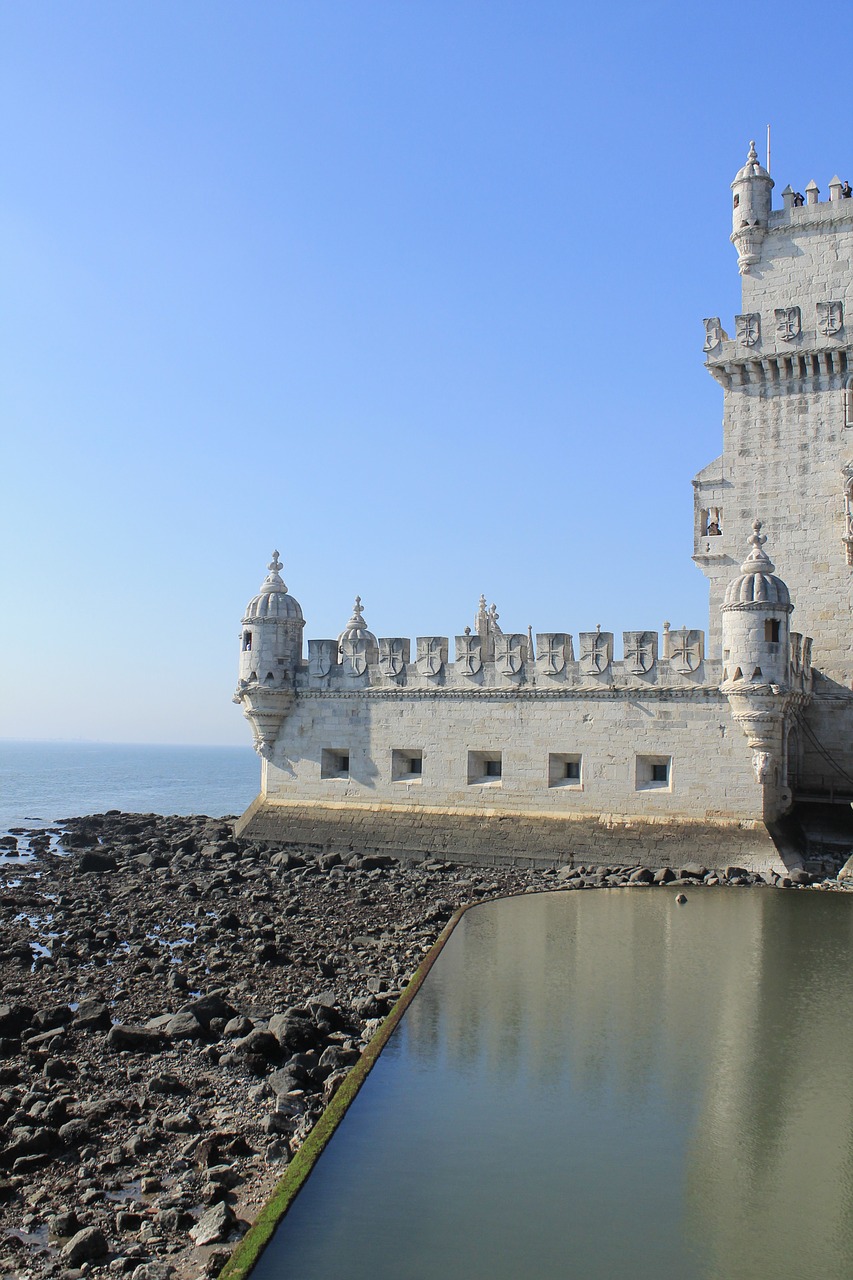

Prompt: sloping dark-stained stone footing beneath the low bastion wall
[{"left": 236, "top": 796, "right": 780, "bottom": 870}]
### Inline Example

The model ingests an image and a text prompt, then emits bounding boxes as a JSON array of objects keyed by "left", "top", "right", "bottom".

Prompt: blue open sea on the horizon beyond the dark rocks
[{"left": 0, "top": 741, "right": 260, "bottom": 833}]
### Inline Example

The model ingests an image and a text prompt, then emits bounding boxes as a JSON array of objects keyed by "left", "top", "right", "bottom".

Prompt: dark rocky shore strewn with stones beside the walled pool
[{"left": 0, "top": 812, "right": 835, "bottom": 1280}]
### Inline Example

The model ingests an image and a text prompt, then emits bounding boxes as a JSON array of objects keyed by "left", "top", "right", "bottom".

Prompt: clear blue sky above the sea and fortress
[{"left": 0, "top": 0, "right": 853, "bottom": 742}]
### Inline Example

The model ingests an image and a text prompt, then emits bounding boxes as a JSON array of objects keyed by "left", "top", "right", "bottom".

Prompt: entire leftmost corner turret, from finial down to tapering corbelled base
[{"left": 234, "top": 552, "right": 305, "bottom": 756}]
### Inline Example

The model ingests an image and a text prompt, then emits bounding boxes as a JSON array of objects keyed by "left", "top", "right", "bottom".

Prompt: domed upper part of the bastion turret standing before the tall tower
[{"left": 722, "top": 520, "right": 794, "bottom": 689}]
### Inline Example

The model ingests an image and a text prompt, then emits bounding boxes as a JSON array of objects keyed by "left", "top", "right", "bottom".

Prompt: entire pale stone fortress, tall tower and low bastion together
[{"left": 234, "top": 147, "right": 853, "bottom": 867}]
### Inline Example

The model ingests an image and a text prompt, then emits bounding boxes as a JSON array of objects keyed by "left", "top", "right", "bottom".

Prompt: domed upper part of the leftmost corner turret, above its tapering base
[{"left": 240, "top": 552, "right": 305, "bottom": 687}]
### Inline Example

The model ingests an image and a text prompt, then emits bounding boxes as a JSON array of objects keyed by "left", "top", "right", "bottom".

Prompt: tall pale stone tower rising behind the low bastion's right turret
[{"left": 694, "top": 145, "right": 853, "bottom": 690}]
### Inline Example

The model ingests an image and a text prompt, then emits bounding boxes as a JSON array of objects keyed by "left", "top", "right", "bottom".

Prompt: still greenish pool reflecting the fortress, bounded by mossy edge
[{"left": 252, "top": 888, "right": 853, "bottom": 1280}]
